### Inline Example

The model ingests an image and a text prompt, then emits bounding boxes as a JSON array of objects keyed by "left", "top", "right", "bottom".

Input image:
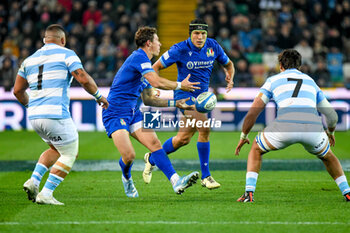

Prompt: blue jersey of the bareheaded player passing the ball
[{"left": 107, "top": 49, "right": 154, "bottom": 110}]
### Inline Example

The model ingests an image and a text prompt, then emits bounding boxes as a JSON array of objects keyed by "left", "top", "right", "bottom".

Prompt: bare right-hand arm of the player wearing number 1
[{"left": 72, "top": 68, "right": 109, "bottom": 109}]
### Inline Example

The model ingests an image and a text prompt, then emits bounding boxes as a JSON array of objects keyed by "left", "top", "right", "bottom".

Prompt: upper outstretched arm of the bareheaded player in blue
[{"left": 144, "top": 72, "right": 200, "bottom": 91}]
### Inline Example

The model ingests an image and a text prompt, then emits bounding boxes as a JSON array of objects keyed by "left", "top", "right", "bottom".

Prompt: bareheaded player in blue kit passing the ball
[{"left": 102, "top": 27, "right": 200, "bottom": 198}]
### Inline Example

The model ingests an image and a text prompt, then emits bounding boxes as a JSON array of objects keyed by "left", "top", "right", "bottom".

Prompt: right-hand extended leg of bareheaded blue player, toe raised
[{"left": 130, "top": 127, "right": 198, "bottom": 194}]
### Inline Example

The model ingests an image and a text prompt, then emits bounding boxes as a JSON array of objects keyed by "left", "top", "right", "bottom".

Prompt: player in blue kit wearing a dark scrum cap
[{"left": 143, "top": 19, "right": 235, "bottom": 189}]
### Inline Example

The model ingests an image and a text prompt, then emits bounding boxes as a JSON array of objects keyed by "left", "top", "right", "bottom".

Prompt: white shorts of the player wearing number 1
[{"left": 30, "top": 118, "right": 78, "bottom": 146}]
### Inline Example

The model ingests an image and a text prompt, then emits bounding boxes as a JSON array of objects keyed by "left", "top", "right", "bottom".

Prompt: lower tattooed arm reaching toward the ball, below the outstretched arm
[{"left": 141, "top": 88, "right": 194, "bottom": 110}]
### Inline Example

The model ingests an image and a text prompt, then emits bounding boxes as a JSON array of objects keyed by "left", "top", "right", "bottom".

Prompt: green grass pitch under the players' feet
[{"left": 0, "top": 132, "right": 350, "bottom": 233}]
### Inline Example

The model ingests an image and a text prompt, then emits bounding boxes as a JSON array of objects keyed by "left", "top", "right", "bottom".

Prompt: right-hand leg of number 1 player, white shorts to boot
[{"left": 36, "top": 118, "right": 79, "bottom": 205}]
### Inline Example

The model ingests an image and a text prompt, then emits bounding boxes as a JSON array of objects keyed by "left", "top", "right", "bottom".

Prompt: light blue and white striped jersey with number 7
[{"left": 260, "top": 69, "right": 325, "bottom": 124}]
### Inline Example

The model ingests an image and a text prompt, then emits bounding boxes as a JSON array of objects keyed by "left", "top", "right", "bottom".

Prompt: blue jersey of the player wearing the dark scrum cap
[{"left": 160, "top": 38, "right": 230, "bottom": 99}]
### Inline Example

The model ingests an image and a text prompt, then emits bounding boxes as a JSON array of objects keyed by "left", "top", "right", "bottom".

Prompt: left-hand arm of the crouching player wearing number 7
[{"left": 235, "top": 92, "right": 269, "bottom": 155}]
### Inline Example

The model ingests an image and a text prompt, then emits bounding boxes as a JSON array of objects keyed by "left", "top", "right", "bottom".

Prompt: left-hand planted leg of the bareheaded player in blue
[{"left": 111, "top": 129, "right": 139, "bottom": 197}]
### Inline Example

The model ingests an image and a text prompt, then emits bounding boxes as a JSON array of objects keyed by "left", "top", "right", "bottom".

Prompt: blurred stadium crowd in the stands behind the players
[{"left": 0, "top": 0, "right": 350, "bottom": 90}]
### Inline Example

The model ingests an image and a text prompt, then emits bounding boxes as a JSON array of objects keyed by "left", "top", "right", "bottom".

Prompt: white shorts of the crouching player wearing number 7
[{"left": 255, "top": 122, "right": 330, "bottom": 157}]
